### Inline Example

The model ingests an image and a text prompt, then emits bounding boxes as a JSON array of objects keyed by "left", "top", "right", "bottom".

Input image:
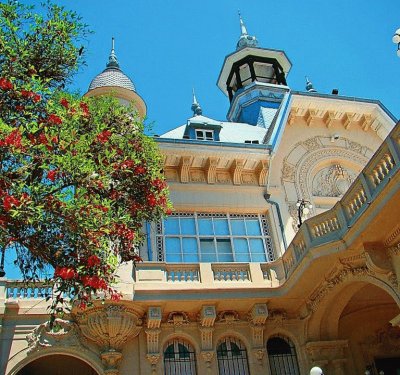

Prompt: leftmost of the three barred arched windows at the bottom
[{"left": 164, "top": 339, "right": 196, "bottom": 375}]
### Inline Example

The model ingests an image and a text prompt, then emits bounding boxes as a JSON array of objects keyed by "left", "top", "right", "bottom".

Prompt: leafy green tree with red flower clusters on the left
[{"left": 0, "top": 1, "right": 170, "bottom": 317}]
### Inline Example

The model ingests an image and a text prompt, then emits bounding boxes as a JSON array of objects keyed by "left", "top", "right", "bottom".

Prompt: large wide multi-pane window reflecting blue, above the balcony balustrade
[{"left": 157, "top": 213, "right": 274, "bottom": 263}]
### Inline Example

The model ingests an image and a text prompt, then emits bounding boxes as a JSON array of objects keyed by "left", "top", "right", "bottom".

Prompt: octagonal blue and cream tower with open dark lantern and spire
[{"left": 217, "top": 14, "right": 292, "bottom": 150}]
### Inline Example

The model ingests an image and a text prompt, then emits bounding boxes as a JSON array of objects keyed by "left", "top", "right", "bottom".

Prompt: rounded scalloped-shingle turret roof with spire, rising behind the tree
[{"left": 85, "top": 38, "right": 146, "bottom": 117}]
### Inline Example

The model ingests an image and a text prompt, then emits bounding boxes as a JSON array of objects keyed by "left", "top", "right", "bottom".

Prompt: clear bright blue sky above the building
[{"left": 6, "top": 0, "right": 400, "bottom": 278}]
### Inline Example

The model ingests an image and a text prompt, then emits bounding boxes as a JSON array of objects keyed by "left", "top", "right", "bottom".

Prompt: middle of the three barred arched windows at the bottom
[{"left": 217, "top": 337, "right": 250, "bottom": 375}]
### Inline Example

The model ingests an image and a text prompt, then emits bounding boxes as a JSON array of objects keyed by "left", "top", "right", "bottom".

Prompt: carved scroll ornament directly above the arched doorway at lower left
[{"left": 26, "top": 319, "right": 83, "bottom": 353}]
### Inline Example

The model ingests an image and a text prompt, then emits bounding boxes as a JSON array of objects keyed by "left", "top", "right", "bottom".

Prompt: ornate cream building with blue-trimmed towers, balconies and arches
[{"left": 0, "top": 16, "right": 400, "bottom": 375}]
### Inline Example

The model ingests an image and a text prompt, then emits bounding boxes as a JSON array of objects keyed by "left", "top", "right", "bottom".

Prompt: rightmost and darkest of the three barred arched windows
[{"left": 267, "top": 336, "right": 300, "bottom": 375}]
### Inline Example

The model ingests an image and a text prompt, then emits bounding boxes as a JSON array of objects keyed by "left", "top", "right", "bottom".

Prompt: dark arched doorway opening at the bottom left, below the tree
[{"left": 16, "top": 354, "right": 98, "bottom": 375}]
